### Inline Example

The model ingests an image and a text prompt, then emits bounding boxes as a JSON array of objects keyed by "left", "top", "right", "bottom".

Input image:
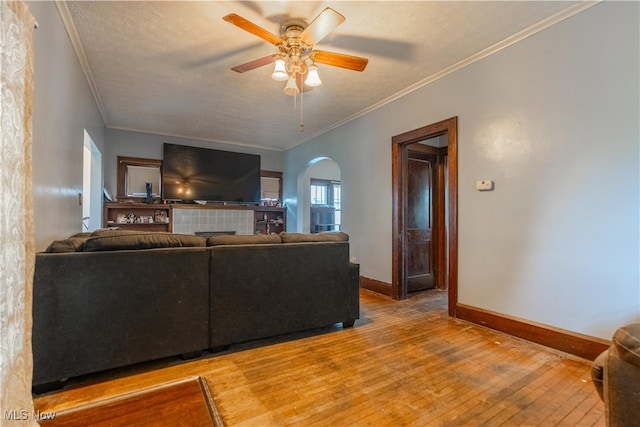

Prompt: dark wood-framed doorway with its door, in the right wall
[{"left": 391, "top": 117, "right": 458, "bottom": 316}]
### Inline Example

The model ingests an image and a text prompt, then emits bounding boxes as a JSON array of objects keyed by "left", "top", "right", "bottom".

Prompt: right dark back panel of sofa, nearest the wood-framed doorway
[{"left": 209, "top": 242, "right": 358, "bottom": 347}]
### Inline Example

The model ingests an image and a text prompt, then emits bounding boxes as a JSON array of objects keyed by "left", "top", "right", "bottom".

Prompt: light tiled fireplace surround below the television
[{"left": 172, "top": 207, "right": 255, "bottom": 234}]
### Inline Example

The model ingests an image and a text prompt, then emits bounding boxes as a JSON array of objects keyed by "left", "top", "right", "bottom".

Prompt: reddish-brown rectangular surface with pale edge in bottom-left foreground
[{"left": 39, "top": 377, "right": 224, "bottom": 427}]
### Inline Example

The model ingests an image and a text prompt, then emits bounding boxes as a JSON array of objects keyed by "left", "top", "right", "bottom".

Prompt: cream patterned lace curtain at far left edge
[{"left": 0, "top": 1, "right": 38, "bottom": 426}]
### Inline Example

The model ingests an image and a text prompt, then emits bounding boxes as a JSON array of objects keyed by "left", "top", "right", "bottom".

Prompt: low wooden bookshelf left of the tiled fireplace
[{"left": 103, "top": 203, "right": 172, "bottom": 231}]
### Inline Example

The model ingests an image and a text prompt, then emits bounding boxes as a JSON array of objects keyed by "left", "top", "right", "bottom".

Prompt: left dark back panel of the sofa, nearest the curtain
[{"left": 33, "top": 247, "right": 210, "bottom": 386}]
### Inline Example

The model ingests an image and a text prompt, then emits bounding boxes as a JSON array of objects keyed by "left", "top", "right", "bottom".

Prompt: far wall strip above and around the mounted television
[{"left": 103, "top": 129, "right": 283, "bottom": 196}]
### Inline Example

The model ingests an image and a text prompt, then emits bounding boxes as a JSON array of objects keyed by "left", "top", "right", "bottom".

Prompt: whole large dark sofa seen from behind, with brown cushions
[{"left": 32, "top": 230, "right": 359, "bottom": 390}]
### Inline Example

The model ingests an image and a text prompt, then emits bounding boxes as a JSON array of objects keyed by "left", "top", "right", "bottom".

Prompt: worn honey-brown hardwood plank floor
[{"left": 34, "top": 291, "right": 605, "bottom": 426}]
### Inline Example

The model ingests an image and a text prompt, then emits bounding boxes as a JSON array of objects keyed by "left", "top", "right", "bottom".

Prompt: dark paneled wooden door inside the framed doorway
[{"left": 405, "top": 147, "right": 438, "bottom": 292}]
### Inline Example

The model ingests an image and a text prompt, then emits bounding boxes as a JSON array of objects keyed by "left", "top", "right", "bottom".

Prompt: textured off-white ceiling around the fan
[{"left": 58, "top": 1, "right": 587, "bottom": 150}]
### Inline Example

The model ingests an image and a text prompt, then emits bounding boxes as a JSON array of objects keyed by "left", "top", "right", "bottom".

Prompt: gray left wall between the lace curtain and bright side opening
[{"left": 26, "top": 1, "right": 104, "bottom": 251}]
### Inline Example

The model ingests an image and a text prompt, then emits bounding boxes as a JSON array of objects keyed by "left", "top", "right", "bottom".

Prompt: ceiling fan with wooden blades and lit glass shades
[{"left": 223, "top": 7, "right": 369, "bottom": 96}]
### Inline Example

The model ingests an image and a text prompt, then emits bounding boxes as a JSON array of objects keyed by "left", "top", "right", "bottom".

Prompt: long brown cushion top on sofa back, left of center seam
[{"left": 84, "top": 230, "right": 206, "bottom": 252}]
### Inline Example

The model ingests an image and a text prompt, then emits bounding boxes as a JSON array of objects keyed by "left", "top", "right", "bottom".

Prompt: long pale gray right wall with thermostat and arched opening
[{"left": 284, "top": 2, "right": 640, "bottom": 339}]
